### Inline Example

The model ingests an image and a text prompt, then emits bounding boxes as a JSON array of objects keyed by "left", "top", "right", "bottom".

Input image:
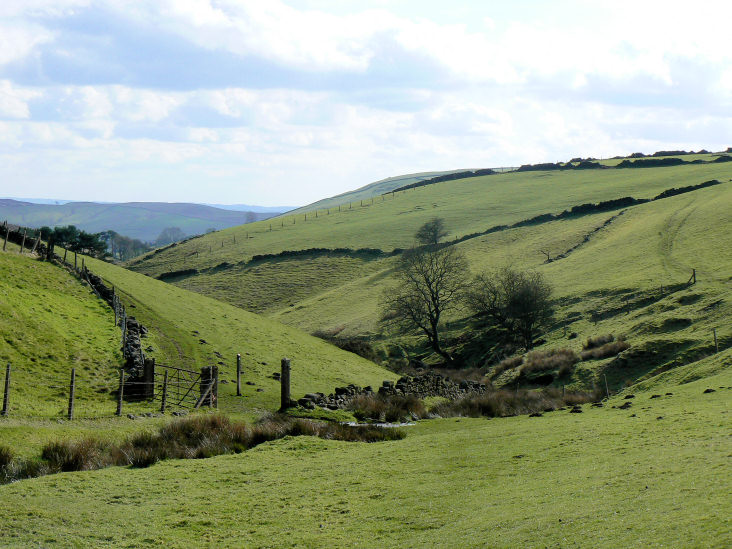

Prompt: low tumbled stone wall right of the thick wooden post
[{"left": 297, "top": 370, "right": 488, "bottom": 410}]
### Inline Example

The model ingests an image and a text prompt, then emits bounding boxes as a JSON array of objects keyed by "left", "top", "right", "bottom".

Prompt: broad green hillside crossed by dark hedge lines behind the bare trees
[{"left": 130, "top": 154, "right": 732, "bottom": 387}]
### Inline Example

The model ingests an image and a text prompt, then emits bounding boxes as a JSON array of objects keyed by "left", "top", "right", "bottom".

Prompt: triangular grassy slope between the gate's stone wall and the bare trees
[{"left": 87, "top": 253, "right": 394, "bottom": 412}]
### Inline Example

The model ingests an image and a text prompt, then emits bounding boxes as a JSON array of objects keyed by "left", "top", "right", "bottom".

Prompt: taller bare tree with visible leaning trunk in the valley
[{"left": 382, "top": 246, "right": 468, "bottom": 362}]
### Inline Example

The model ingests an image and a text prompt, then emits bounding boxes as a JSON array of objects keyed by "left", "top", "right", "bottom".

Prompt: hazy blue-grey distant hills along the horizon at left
[{"left": 0, "top": 199, "right": 280, "bottom": 241}]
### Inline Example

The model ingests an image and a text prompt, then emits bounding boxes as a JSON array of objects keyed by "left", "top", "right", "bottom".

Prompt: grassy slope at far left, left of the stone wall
[{"left": 0, "top": 244, "right": 122, "bottom": 416}]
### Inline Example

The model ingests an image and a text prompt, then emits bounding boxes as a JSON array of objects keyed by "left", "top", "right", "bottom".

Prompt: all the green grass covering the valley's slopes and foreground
[{"left": 0, "top": 152, "right": 732, "bottom": 548}]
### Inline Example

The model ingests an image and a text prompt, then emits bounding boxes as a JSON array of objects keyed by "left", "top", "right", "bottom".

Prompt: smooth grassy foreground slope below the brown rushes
[{"left": 0, "top": 358, "right": 732, "bottom": 547}]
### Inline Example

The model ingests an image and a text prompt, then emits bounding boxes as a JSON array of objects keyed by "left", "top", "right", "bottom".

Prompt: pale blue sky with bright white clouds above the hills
[{"left": 0, "top": 0, "right": 732, "bottom": 206}]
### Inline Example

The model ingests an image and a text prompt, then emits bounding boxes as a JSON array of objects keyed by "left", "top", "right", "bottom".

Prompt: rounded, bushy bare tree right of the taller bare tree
[{"left": 467, "top": 267, "right": 553, "bottom": 350}]
